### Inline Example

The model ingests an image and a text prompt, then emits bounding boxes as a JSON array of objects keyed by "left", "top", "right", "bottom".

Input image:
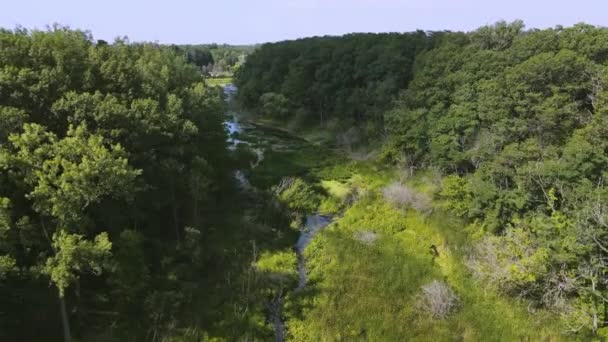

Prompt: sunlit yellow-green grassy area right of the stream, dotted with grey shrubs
[{"left": 278, "top": 163, "right": 564, "bottom": 341}]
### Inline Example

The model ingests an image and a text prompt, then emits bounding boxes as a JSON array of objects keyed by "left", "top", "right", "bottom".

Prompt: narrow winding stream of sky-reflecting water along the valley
[{"left": 224, "top": 85, "right": 332, "bottom": 342}]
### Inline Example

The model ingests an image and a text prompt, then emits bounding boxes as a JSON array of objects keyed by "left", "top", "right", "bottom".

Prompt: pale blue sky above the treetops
[{"left": 0, "top": 0, "right": 608, "bottom": 44}]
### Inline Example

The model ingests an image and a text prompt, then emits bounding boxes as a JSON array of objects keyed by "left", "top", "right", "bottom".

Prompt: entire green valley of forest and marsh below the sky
[{"left": 0, "top": 21, "right": 608, "bottom": 342}]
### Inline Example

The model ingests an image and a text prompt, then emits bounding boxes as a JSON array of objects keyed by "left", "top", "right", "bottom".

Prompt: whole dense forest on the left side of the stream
[{"left": 0, "top": 26, "right": 288, "bottom": 341}]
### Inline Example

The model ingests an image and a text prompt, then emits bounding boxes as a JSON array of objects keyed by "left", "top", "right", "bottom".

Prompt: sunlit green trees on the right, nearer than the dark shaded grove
[{"left": 385, "top": 22, "right": 608, "bottom": 331}]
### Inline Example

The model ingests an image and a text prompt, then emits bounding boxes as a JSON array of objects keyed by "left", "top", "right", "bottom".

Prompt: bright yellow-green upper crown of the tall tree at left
[{"left": 10, "top": 124, "right": 140, "bottom": 225}]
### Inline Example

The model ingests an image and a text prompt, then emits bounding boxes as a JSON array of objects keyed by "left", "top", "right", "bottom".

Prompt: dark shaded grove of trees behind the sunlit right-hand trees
[{"left": 235, "top": 31, "right": 430, "bottom": 130}]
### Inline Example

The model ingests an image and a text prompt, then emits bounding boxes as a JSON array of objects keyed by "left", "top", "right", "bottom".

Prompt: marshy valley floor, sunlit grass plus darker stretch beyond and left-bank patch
[{"left": 235, "top": 117, "right": 576, "bottom": 341}]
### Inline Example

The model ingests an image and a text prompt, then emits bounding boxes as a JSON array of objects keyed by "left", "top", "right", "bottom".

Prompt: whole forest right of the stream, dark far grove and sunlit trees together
[{"left": 236, "top": 21, "right": 608, "bottom": 339}]
